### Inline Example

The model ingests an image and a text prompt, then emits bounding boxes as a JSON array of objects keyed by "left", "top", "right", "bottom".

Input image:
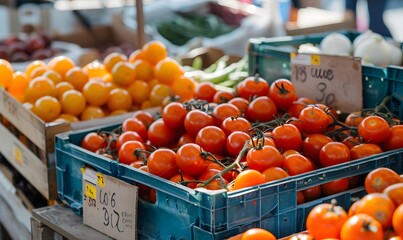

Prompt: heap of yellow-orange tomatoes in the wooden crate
[{"left": 0, "top": 42, "right": 195, "bottom": 122}]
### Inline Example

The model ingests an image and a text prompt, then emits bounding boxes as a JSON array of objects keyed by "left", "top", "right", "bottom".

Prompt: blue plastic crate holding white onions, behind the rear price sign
[{"left": 248, "top": 31, "right": 389, "bottom": 108}]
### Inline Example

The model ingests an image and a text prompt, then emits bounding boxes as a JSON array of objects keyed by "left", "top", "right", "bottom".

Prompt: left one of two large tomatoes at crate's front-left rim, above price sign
[{"left": 147, "top": 148, "right": 178, "bottom": 179}]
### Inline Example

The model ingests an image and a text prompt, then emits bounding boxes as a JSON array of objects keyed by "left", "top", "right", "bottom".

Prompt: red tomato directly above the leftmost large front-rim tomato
[{"left": 148, "top": 118, "right": 176, "bottom": 148}]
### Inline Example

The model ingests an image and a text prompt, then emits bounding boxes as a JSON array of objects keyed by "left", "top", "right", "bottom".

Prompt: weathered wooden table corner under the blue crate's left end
[{"left": 31, "top": 205, "right": 112, "bottom": 240}]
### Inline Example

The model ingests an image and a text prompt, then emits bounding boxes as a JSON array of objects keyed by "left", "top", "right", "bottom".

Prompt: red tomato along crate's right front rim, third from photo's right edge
[{"left": 319, "top": 142, "right": 350, "bottom": 167}]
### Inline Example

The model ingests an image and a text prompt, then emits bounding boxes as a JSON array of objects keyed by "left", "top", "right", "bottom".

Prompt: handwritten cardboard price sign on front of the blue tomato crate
[{"left": 82, "top": 168, "right": 138, "bottom": 239}]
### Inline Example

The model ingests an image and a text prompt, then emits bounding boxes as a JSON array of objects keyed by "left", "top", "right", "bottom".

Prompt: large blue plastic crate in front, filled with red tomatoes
[{"left": 56, "top": 126, "right": 403, "bottom": 240}]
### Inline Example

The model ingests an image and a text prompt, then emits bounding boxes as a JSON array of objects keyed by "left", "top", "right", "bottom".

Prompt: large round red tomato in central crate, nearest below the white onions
[{"left": 358, "top": 116, "right": 391, "bottom": 144}]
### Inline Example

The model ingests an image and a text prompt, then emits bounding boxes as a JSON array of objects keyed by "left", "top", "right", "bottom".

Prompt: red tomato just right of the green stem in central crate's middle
[{"left": 271, "top": 123, "right": 302, "bottom": 151}]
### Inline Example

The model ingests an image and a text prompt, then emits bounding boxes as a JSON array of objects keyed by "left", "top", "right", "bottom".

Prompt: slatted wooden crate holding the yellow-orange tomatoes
[{"left": 0, "top": 88, "right": 144, "bottom": 200}]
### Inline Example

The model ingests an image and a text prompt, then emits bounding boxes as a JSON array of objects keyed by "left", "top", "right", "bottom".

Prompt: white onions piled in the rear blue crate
[{"left": 298, "top": 30, "right": 402, "bottom": 67}]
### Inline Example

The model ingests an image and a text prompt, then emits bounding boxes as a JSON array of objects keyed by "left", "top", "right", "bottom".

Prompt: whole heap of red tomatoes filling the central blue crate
[{"left": 82, "top": 73, "right": 403, "bottom": 203}]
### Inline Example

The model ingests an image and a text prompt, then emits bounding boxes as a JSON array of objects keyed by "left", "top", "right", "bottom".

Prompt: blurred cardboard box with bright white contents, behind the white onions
[{"left": 285, "top": 7, "right": 355, "bottom": 36}]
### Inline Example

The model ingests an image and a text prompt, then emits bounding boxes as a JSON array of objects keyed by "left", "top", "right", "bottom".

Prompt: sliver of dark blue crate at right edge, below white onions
[{"left": 387, "top": 66, "right": 403, "bottom": 119}]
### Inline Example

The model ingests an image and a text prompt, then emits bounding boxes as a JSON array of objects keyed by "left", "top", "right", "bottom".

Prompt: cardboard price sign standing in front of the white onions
[{"left": 291, "top": 53, "right": 363, "bottom": 112}]
